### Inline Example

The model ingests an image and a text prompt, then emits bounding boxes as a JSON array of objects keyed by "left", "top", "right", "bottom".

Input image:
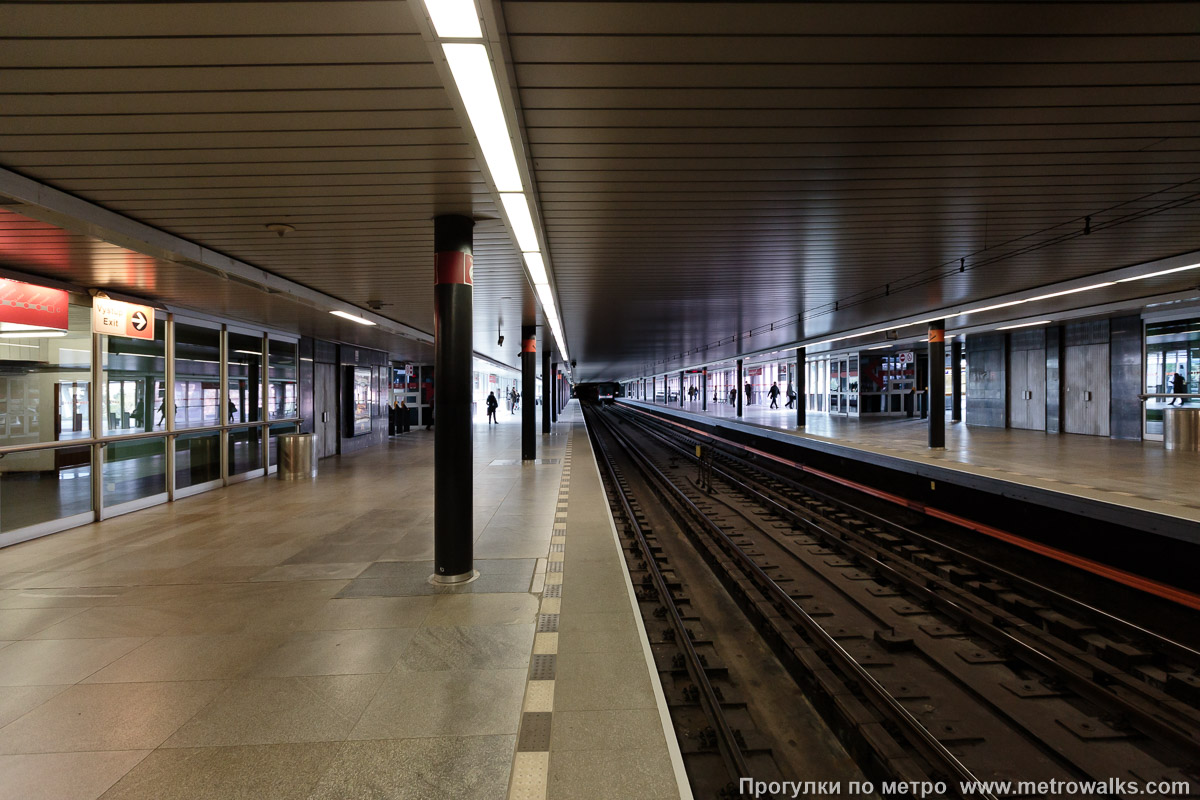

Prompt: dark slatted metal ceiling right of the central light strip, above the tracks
[{"left": 500, "top": 0, "right": 1200, "bottom": 380}]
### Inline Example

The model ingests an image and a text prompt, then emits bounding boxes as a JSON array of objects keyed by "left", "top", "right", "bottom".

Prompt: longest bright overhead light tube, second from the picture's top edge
[{"left": 442, "top": 43, "right": 518, "bottom": 191}]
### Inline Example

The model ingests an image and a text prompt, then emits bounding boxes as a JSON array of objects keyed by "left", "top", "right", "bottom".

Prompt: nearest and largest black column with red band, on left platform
[{"left": 433, "top": 216, "right": 475, "bottom": 583}]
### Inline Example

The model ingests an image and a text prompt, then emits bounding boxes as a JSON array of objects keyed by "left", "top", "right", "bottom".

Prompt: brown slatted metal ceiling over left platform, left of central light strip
[{"left": 0, "top": 0, "right": 536, "bottom": 374}]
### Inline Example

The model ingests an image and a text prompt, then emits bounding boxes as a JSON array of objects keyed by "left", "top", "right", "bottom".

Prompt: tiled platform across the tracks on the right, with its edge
[{"left": 620, "top": 398, "right": 1200, "bottom": 541}]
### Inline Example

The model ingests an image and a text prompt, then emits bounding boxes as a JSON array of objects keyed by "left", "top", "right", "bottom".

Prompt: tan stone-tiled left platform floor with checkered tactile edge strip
[{"left": 0, "top": 404, "right": 690, "bottom": 800}]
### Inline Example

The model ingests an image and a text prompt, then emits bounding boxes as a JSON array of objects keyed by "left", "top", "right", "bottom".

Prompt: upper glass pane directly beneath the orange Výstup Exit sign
[{"left": 100, "top": 319, "right": 167, "bottom": 434}]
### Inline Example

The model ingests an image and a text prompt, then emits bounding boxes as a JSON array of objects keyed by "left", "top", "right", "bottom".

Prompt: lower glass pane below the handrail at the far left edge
[{"left": 0, "top": 445, "right": 92, "bottom": 533}]
